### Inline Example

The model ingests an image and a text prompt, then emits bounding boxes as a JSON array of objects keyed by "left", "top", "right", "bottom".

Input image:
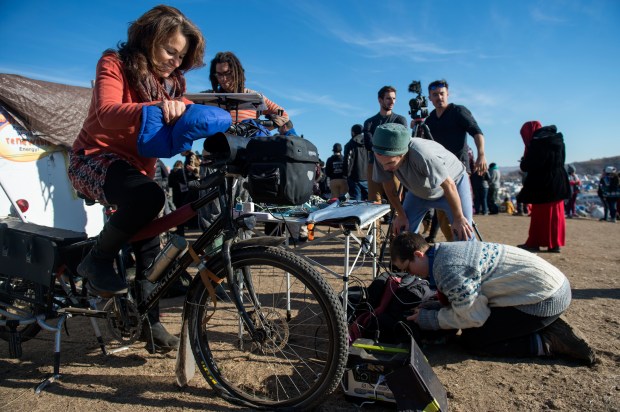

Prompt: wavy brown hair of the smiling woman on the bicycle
[{"left": 114, "top": 5, "right": 206, "bottom": 92}]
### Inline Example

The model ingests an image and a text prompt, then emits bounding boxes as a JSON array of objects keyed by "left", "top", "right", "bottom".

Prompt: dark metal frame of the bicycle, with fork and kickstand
[{"left": 0, "top": 162, "right": 283, "bottom": 393}]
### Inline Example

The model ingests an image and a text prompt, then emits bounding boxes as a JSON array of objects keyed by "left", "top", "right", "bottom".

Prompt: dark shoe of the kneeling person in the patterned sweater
[{"left": 540, "top": 318, "right": 596, "bottom": 365}]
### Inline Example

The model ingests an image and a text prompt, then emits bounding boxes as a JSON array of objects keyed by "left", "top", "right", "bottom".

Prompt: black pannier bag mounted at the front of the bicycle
[{"left": 246, "top": 135, "right": 319, "bottom": 205}]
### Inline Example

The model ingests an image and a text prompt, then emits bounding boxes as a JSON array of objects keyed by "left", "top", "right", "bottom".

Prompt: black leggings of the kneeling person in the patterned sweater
[{"left": 461, "top": 307, "right": 560, "bottom": 357}]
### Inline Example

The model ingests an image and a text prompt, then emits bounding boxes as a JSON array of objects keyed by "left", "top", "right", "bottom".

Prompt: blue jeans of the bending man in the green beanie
[{"left": 403, "top": 175, "right": 476, "bottom": 240}]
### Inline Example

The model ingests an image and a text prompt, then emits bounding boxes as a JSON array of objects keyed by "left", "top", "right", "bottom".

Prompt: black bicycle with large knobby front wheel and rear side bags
[{"left": 0, "top": 128, "right": 348, "bottom": 410}]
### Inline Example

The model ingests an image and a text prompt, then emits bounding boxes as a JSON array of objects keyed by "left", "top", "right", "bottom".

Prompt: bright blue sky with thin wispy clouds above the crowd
[{"left": 0, "top": 0, "right": 620, "bottom": 166}]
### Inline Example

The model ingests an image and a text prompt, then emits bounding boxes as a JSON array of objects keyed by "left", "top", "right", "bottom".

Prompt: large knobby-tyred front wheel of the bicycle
[{"left": 188, "top": 246, "right": 348, "bottom": 410}]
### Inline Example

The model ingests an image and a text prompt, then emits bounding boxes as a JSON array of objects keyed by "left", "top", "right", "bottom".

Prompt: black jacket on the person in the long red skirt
[{"left": 517, "top": 126, "right": 570, "bottom": 204}]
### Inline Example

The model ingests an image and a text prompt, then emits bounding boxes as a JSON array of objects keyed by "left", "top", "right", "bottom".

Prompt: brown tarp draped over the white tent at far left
[{"left": 0, "top": 73, "right": 92, "bottom": 147}]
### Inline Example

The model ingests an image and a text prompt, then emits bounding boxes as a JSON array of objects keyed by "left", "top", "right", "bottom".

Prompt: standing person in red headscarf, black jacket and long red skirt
[{"left": 517, "top": 120, "right": 570, "bottom": 253}]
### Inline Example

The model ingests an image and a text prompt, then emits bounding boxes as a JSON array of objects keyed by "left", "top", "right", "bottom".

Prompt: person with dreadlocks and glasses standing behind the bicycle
[{"left": 203, "top": 51, "right": 289, "bottom": 127}]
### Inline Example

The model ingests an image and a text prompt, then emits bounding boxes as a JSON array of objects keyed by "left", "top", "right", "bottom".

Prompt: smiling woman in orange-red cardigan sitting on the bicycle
[{"left": 68, "top": 5, "right": 205, "bottom": 348}]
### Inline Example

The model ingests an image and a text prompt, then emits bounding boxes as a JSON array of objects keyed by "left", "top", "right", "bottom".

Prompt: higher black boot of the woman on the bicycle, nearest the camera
[{"left": 77, "top": 246, "right": 127, "bottom": 298}]
